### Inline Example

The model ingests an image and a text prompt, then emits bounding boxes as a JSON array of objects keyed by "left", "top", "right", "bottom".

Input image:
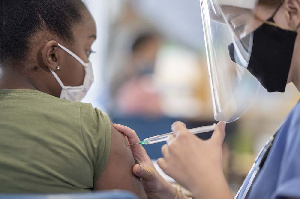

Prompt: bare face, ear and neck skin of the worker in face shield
[{"left": 225, "top": 0, "right": 300, "bottom": 91}]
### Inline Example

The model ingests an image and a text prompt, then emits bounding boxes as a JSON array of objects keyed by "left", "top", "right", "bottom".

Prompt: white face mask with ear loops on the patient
[{"left": 50, "top": 44, "right": 94, "bottom": 102}]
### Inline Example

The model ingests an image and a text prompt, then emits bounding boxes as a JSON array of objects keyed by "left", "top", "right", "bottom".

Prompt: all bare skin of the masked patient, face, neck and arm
[{"left": 0, "top": 5, "right": 146, "bottom": 198}]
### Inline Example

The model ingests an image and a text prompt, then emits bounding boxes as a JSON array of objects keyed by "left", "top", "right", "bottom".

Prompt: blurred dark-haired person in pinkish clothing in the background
[{"left": 111, "top": 32, "right": 162, "bottom": 116}]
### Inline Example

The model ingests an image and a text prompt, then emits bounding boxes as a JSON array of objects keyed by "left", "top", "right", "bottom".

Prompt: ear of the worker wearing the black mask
[{"left": 283, "top": 0, "right": 300, "bottom": 30}]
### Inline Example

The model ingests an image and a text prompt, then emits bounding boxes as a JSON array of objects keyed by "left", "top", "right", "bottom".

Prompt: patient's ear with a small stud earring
[{"left": 42, "top": 40, "right": 59, "bottom": 71}]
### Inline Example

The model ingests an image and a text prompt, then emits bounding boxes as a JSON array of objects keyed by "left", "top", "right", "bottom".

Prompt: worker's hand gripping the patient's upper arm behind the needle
[{"left": 114, "top": 124, "right": 176, "bottom": 198}]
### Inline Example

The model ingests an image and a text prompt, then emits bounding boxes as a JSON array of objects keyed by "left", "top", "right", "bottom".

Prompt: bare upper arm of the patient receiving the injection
[{"left": 94, "top": 125, "right": 147, "bottom": 198}]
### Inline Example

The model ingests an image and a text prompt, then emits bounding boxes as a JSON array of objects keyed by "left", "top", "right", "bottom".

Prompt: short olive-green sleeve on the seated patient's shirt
[{"left": 80, "top": 103, "right": 111, "bottom": 181}]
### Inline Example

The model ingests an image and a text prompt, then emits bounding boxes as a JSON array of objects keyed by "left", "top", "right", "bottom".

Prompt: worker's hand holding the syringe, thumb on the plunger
[{"left": 157, "top": 122, "right": 231, "bottom": 198}]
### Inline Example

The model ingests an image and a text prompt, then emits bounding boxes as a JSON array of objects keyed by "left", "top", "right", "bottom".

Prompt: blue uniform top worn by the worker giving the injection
[{"left": 237, "top": 102, "right": 300, "bottom": 199}]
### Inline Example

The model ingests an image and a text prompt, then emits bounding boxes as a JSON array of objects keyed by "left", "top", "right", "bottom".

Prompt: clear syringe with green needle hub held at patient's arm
[{"left": 132, "top": 124, "right": 217, "bottom": 145}]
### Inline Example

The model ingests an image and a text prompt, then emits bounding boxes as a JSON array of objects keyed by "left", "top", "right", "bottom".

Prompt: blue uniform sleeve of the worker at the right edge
[{"left": 273, "top": 110, "right": 300, "bottom": 198}]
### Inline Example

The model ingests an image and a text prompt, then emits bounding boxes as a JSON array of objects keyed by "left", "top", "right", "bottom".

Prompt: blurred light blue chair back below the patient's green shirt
[{"left": 0, "top": 190, "right": 137, "bottom": 199}]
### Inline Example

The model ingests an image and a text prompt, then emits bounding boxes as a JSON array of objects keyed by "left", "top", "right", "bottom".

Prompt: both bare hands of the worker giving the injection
[{"left": 114, "top": 122, "right": 233, "bottom": 199}]
